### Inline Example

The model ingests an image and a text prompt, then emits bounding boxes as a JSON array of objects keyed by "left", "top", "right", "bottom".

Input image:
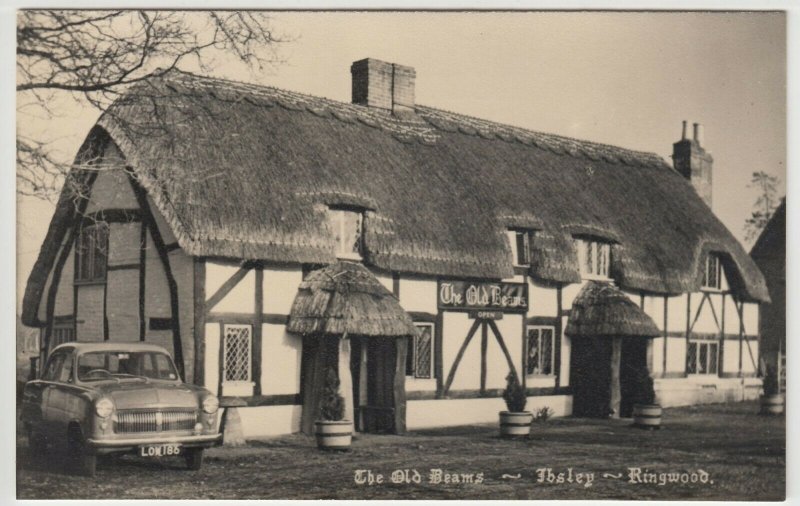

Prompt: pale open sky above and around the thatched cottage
[{"left": 12, "top": 12, "right": 787, "bottom": 309}]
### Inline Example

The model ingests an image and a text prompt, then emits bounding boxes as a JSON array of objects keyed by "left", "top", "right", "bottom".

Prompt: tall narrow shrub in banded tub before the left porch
[{"left": 314, "top": 367, "right": 353, "bottom": 451}]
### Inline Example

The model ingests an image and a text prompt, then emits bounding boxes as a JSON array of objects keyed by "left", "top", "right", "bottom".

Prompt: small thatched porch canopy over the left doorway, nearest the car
[{"left": 286, "top": 261, "right": 415, "bottom": 337}]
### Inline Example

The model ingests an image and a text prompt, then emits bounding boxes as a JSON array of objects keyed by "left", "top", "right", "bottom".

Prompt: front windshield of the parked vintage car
[{"left": 78, "top": 351, "right": 178, "bottom": 381}]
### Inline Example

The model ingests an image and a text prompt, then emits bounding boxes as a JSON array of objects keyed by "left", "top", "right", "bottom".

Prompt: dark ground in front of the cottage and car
[{"left": 17, "top": 402, "right": 786, "bottom": 500}]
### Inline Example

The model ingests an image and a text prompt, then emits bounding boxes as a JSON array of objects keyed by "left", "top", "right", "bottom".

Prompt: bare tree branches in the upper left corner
[{"left": 17, "top": 10, "right": 285, "bottom": 199}]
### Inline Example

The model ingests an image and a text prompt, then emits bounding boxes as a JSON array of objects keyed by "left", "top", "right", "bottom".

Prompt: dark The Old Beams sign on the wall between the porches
[{"left": 436, "top": 280, "right": 528, "bottom": 313}]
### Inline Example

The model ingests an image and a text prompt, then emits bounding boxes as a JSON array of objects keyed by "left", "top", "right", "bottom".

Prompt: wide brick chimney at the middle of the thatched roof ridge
[{"left": 350, "top": 58, "right": 417, "bottom": 113}]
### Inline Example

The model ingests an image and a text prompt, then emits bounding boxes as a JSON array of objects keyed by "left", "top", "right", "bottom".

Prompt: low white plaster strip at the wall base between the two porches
[{"left": 406, "top": 395, "right": 572, "bottom": 430}]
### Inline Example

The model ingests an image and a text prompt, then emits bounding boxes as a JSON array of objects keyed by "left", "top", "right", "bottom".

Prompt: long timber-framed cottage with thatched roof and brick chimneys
[{"left": 23, "top": 59, "right": 768, "bottom": 434}]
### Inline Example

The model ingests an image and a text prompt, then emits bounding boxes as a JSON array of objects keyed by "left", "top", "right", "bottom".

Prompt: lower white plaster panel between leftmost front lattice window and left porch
[{"left": 261, "top": 324, "right": 303, "bottom": 395}]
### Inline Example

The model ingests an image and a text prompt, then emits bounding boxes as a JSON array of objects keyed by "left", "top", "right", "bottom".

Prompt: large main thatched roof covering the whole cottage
[{"left": 20, "top": 72, "right": 767, "bottom": 326}]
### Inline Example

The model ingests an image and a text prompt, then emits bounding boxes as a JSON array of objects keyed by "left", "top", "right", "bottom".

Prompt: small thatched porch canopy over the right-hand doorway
[{"left": 564, "top": 281, "right": 660, "bottom": 338}]
